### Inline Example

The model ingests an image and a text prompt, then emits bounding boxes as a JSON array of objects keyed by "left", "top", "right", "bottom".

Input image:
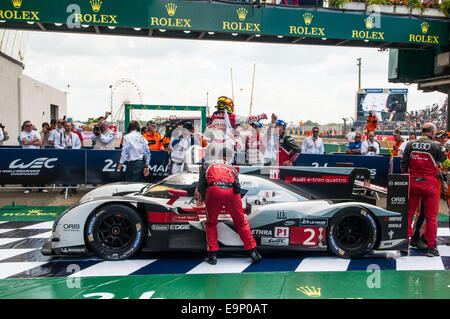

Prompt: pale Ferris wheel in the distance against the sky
[{"left": 110, "top": 78, "right": 143, "bottom": 123}]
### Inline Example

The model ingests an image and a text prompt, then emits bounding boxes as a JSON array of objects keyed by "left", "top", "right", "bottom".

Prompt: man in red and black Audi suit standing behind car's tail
[{"left": 400, "top": 123, "right": 450, "bottom": 257}]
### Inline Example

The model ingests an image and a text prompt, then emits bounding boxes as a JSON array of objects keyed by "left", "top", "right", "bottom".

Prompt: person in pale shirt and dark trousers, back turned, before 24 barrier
[{"left": 117, "top": 121, "right": 151, "bottom": 182}]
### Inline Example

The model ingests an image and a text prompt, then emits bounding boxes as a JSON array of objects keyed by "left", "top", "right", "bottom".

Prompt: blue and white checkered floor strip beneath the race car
[{"left": 0, "top": 222, "right": 450, "bottom": 279}]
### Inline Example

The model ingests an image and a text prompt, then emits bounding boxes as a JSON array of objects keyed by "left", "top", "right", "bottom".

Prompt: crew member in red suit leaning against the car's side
[{"left": 197, "top": 148, "right": 261, "bottom": 265}]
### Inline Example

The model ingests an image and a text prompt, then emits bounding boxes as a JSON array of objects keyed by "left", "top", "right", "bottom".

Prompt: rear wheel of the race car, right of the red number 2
[{"left": 327, "top": 207, "right": 378, "bottom": 259}]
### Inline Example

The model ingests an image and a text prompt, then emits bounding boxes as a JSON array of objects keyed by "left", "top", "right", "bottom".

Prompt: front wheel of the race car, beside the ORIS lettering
[{"left": 85, "top": 204, "right": 146, "bottom": 260}]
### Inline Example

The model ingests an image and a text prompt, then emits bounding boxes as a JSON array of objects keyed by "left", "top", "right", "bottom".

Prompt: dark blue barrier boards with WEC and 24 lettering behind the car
[{"left": 0, "top": 148, "right": 400, "bottom": 190}]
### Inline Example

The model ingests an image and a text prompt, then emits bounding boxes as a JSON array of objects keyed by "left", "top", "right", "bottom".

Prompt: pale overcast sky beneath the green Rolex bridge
[{"left": 25, "top": 32, "right": 446, "bottom": 124}]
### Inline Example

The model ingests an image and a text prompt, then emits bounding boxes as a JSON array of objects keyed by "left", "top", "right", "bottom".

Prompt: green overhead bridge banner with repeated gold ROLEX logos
[{"left": 0, "top": 0, "right": 449, "bottom": 46}]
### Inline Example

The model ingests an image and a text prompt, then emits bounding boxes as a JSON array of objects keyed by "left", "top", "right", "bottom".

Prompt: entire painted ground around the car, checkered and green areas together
[{"left": 0, "top": 206, "right": 450, "bottom": 300}]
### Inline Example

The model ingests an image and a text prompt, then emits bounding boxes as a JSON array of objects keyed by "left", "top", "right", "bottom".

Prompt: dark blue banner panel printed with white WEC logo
[{"left": 0, "top": 149, "right": 86, "bottom": 185}]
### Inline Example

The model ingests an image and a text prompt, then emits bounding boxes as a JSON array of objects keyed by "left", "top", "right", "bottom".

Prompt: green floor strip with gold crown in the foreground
[{"left": 0, "top": 269, "right": 450, "bottom": 302}]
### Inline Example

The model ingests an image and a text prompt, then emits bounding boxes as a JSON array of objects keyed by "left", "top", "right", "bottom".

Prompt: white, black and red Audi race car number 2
[{"left": 41, "top": 165, "right": 407, "bottom": 260}]
